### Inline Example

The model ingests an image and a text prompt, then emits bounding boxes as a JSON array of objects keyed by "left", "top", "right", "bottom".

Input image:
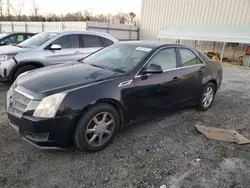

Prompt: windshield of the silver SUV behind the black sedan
[{"left": 18, "top": 32, "right": 58, "bottom": 48}]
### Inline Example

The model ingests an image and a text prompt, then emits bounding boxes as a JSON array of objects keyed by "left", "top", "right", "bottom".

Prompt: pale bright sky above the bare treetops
[{"left": 8, "top": 0, "right": 141, "bottom": 16}]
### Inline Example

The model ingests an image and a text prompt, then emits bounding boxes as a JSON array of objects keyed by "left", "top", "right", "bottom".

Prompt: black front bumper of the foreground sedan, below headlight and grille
[{"left": 8, "top": 113, "right": 77, "bottom": 149}]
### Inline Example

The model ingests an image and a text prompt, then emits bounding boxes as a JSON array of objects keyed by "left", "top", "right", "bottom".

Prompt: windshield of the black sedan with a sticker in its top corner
[{"left": 82, "top": 43, "right": 152, "bottom": 73}]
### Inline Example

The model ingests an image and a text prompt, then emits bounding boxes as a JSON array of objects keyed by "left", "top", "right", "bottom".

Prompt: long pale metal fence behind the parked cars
[{"left": 0, "top": 21, "right": 139, "bottom": 40}]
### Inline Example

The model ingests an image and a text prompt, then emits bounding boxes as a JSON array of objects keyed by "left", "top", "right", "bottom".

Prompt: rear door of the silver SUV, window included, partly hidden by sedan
[{"left": 81, "top": 34, "right": 104, "bottom": 56}]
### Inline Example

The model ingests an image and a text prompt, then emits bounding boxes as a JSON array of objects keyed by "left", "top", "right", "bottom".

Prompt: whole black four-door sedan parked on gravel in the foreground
[{"left": 6, "top": 41, "right": 222, "bottom": 152}]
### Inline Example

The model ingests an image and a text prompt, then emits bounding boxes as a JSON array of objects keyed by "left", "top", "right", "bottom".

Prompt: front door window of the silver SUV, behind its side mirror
[{"left": 53, "top": 35, "right": 79, "bottom": 49}]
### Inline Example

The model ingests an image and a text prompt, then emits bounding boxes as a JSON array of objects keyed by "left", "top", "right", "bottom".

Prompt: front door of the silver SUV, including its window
[{"left": 45, "top": 34, "right": 83, "bottom": 64}]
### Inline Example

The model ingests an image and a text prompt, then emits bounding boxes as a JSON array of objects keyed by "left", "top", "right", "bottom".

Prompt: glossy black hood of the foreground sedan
[{"left": 16, "top": 62, "right": 121, "bottom": 98}]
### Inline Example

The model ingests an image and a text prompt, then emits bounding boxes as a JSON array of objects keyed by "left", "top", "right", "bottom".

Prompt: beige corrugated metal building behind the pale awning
[{"left": 139, "top": 0, "right": 250, "bottom": 60}]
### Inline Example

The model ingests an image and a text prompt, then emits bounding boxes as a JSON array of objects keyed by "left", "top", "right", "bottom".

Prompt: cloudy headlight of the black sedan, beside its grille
[{"left": 33, "top": 93, "right": 66, "bottom": 118}]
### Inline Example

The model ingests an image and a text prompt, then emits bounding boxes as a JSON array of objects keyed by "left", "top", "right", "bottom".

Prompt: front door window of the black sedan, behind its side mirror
[{"left": 149, "top": 48, "right": 177, "bottom": 70}]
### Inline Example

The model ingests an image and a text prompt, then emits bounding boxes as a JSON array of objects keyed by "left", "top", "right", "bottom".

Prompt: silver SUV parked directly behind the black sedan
[{"left": 0, "top": 30, "right": 117, "bottom": 81}]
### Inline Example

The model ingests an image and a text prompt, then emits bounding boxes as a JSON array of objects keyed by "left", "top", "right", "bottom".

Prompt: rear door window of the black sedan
[{"left": 179, "top": 49, "right": 202, "bottom": 67}]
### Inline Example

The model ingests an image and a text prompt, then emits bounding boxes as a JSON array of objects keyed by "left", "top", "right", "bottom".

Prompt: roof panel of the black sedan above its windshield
[{"left": 120, "top": 41, "right": 187, "bottom": 48}]
